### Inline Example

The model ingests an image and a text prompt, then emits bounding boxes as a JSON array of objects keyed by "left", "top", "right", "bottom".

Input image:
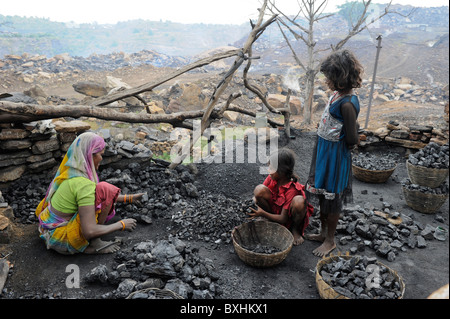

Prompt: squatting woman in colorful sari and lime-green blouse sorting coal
[{"left": 36, "top": 132, "right": 143, "bottom": 254}]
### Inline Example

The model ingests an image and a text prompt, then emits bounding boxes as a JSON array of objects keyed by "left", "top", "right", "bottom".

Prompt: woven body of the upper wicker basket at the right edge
[{"left": 406, "top": 161, "right": 448, "bottom": 188}]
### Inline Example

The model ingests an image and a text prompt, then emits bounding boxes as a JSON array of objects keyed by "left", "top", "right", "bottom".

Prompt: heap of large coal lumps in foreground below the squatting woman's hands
[{"left": 84, "top": 236, "right": 221, "bottom": 299}]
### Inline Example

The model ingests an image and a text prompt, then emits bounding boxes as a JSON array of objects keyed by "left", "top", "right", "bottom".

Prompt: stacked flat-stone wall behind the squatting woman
[{"left": 0, "top": 120, "right": 152, "bottom": 188}]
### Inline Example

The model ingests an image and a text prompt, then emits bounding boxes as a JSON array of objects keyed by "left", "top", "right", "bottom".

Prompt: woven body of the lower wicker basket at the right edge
[{"left": 402, "top": 186, "right": 448, "bottom": 214}]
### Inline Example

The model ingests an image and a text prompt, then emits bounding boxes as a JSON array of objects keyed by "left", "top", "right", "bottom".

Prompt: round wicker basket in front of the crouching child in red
[{"left": 231, "top": 220, "right": 294, "bottom": 267}]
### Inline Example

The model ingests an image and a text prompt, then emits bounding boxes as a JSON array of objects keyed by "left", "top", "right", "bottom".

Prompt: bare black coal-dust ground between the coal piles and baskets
[{"left": 0, "top": 131, "right": 449, "bottom": 301}]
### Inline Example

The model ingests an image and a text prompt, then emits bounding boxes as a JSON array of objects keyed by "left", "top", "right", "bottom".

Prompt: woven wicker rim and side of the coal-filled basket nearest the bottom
[{"left": 316, "top": 255, "right": 405, "bottom": 299}]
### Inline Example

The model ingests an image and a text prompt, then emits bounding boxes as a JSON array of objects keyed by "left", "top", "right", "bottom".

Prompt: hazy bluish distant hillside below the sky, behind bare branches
[{"left": 0, "top": 4, "right": 449, "bottom": 63}]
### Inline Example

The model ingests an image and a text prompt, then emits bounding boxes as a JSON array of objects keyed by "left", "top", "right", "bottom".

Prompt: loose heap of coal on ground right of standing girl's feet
[{"left": 308, "top": 202, "right": 443, "bottom": 261}]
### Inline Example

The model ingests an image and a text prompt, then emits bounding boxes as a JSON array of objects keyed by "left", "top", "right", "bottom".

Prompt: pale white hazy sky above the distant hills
[{"left": 0, "top": 0, "right": 448, "bottom": 24}]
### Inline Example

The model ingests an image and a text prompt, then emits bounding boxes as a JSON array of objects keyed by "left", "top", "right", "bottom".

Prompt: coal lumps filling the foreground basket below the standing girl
[{"left": 320, "top": 256, "right": 402, "bottom": 299}]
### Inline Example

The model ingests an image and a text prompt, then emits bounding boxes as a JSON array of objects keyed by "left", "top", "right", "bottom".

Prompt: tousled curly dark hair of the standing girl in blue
[{"left": 320, "top": 50, "right": 364, "bottom": 92}]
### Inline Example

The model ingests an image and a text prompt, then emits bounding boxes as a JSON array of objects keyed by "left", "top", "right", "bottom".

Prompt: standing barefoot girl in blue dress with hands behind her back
[{"left": 306, "top": 50, "right": 363, "bottom": 257}]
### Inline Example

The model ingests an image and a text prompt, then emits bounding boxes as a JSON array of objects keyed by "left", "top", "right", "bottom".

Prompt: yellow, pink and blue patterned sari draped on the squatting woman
[{"left": 35, "top": 132, "right": 105, "bottom": 254}]
